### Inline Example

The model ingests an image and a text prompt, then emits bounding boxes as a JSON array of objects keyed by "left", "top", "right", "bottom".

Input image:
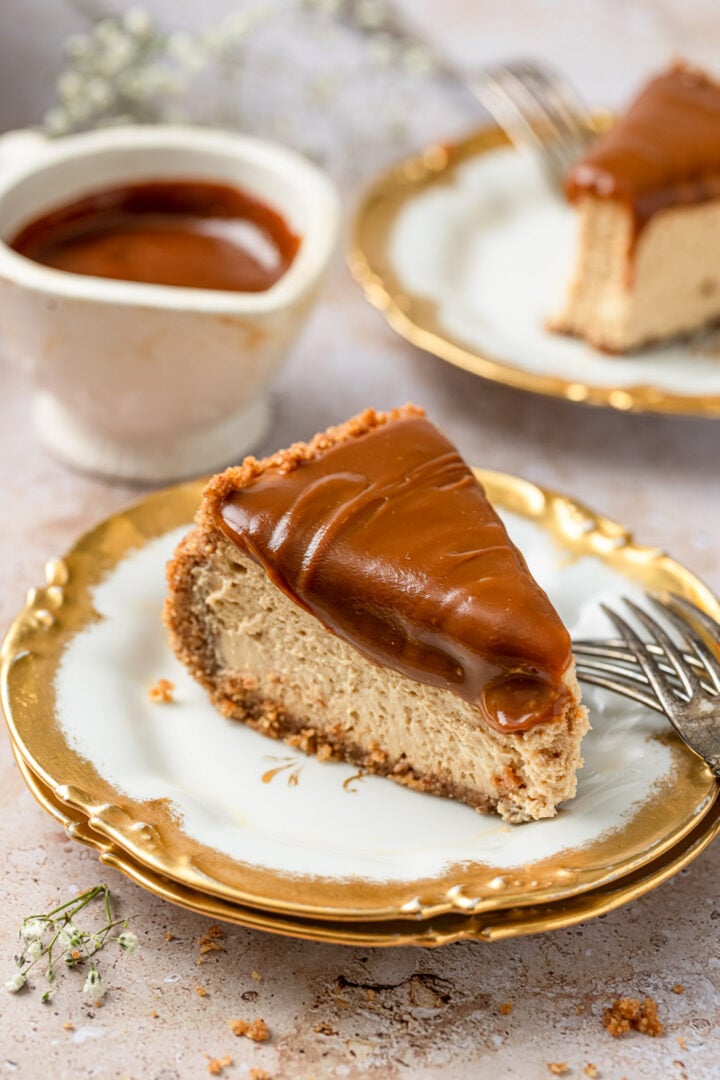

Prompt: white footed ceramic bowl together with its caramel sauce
[{"left": 0, "top": 125, "right": 339, "bottom": 482}]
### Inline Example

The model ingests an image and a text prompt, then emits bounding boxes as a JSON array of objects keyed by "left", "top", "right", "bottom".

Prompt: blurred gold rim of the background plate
[{"left": 348, "top": 118, "right": 720, "bottom": 418}]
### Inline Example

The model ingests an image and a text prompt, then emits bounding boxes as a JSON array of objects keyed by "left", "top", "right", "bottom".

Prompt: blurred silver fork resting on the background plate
[{"left": 338, "top": 0, "right": 596, "bottom": 192}]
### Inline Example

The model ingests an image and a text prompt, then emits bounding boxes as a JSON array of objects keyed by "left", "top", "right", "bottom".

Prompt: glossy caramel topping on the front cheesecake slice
[{"left": 218, "top": 407, "right": 570, "bottom": 731}]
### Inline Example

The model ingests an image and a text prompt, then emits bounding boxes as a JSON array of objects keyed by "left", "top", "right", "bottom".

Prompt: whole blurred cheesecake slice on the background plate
[{"left": 549, "top": 65, "right": 720, "bottom": 353}]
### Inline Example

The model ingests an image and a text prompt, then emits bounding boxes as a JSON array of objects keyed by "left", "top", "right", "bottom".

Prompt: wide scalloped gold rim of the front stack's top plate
[{"left": 0, "top": 471, "right": 720, "bottom": 922}]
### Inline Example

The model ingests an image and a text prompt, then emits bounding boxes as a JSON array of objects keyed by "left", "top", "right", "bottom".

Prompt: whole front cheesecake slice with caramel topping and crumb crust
[{"left": 165, "top": 406, "right": 588, "bottom": 822}]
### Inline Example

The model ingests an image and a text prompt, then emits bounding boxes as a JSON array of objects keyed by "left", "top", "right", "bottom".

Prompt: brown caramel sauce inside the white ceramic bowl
[{"left": 10, "top": 179, "right": 300, "bottom": 293}]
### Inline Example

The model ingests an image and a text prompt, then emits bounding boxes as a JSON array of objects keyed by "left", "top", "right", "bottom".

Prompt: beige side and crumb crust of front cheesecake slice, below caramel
[{"left": 167, "top": 529, "right": 588, "bottom": 822}]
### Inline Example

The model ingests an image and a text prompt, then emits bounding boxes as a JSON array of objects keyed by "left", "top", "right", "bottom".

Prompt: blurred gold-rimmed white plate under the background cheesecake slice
[{"left": 349, "top": 129, "right": 720, "bottom": 417}]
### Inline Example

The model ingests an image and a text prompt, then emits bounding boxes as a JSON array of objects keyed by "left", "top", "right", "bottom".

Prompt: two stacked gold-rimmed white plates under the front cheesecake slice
[{"left": 2, "top": 472, "right": 720, "bottom": 945}]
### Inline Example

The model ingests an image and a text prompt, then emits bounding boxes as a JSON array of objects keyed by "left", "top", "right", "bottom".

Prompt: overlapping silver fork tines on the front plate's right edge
[{"left": 573, "top": 594, "right": 720, "bottom": 779}]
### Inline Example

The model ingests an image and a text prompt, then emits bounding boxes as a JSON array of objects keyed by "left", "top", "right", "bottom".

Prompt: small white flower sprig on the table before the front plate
[{"left": 5, "top": 885, "right": 137, "bottom": 1002}]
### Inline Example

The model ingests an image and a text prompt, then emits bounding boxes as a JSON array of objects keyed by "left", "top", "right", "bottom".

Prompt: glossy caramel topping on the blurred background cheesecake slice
[{"left": 566, "top": 64, "right": 720, "bottom": 233}]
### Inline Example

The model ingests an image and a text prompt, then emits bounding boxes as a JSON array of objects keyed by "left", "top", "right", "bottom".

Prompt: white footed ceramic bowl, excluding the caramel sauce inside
[{"left": 0, "top": 125, "right": 339, "bottom": 482}]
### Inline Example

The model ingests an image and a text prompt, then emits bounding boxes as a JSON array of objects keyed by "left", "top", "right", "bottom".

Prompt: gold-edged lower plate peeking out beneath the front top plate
[{"left": 13, "top": 746, "right": 720, "bottom": 946}]
